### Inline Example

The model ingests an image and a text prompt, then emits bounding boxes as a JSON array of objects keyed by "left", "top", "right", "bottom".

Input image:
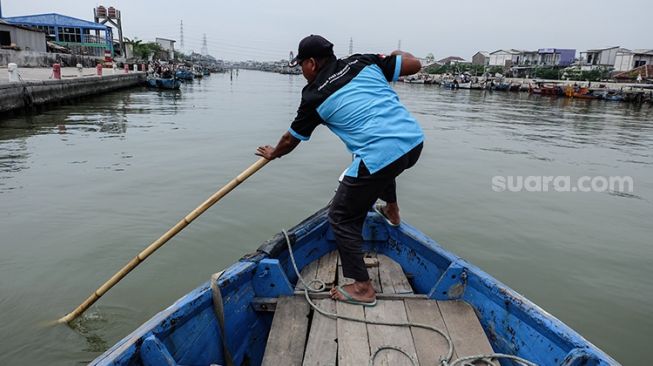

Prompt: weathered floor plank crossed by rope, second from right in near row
[{"left": 404, "top": 299, "right": 449, "bottom": 365}]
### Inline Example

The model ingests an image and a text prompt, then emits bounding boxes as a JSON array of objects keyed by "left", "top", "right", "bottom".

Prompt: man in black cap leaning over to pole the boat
[{"left": 256, "top": 35, "right": 424, "bottom": 306}]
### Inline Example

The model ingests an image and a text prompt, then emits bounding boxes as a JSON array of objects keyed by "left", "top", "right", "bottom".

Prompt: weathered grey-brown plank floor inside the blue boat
[{"left": 262, "top": 251, "right": 498, "bottom": 366}]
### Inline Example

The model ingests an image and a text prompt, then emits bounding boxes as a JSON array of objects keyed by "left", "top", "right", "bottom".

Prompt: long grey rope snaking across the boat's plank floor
[{"left": 281, "top": 229, "right": 537, "bottom": 366}]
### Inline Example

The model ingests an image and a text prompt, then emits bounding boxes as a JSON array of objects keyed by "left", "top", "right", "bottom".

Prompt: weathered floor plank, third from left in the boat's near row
[{"left": 336, "top": 301, "right": 370, "bottom": 365}]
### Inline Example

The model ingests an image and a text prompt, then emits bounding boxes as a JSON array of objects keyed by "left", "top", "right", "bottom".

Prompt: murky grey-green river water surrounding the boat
[{"left": 0, "top": 71, "right": 653, "bottom": 365}]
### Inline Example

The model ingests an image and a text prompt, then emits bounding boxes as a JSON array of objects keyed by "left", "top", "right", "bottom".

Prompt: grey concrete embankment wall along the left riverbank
[{"left": 0, "top": 72, "right": 145, "bottom": 114}]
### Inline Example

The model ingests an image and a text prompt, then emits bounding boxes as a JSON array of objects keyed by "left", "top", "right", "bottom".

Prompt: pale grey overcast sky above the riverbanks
[{"left": 0, "top": 0, "right": 653, "bottom": 60}]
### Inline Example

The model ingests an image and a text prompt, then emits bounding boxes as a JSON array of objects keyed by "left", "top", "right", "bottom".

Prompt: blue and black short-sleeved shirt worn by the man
[{"left": 288, "top": 54, "right": 424, "bottom": 177}]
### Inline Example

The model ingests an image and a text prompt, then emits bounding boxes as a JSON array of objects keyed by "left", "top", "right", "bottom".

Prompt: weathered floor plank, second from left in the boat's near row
[{"left": 300, "top": 298, "right": 338, "bottom": 366}]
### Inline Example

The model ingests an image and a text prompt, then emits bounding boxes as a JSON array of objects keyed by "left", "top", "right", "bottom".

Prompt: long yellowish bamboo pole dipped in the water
[{"left": 57, "top": 158, "right": 269, "bottom": 323}]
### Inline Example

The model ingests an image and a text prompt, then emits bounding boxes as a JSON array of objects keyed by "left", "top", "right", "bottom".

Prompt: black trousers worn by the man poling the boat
[{"left": 329, "top": 143, "right": 423, "bottom": 281}]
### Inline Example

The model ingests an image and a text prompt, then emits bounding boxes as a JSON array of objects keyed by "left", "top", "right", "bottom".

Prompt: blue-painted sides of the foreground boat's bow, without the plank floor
[{"left": 92, "top": 208, "right": 618, "bottom": 366}]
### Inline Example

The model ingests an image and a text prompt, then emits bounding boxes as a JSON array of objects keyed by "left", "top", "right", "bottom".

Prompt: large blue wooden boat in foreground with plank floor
[{"left": 91, "top": 208, "right": 617, "bottom": 366}]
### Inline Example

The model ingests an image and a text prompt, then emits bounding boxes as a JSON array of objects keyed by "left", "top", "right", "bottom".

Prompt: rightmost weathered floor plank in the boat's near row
[{"left": 438, "top": 300, "right": 499, "bottom": 365}]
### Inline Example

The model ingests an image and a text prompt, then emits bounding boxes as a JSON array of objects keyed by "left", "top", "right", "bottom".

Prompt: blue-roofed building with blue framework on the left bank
[{"left": 3, "top": 13, "right": 113, "bottom": 57}]
